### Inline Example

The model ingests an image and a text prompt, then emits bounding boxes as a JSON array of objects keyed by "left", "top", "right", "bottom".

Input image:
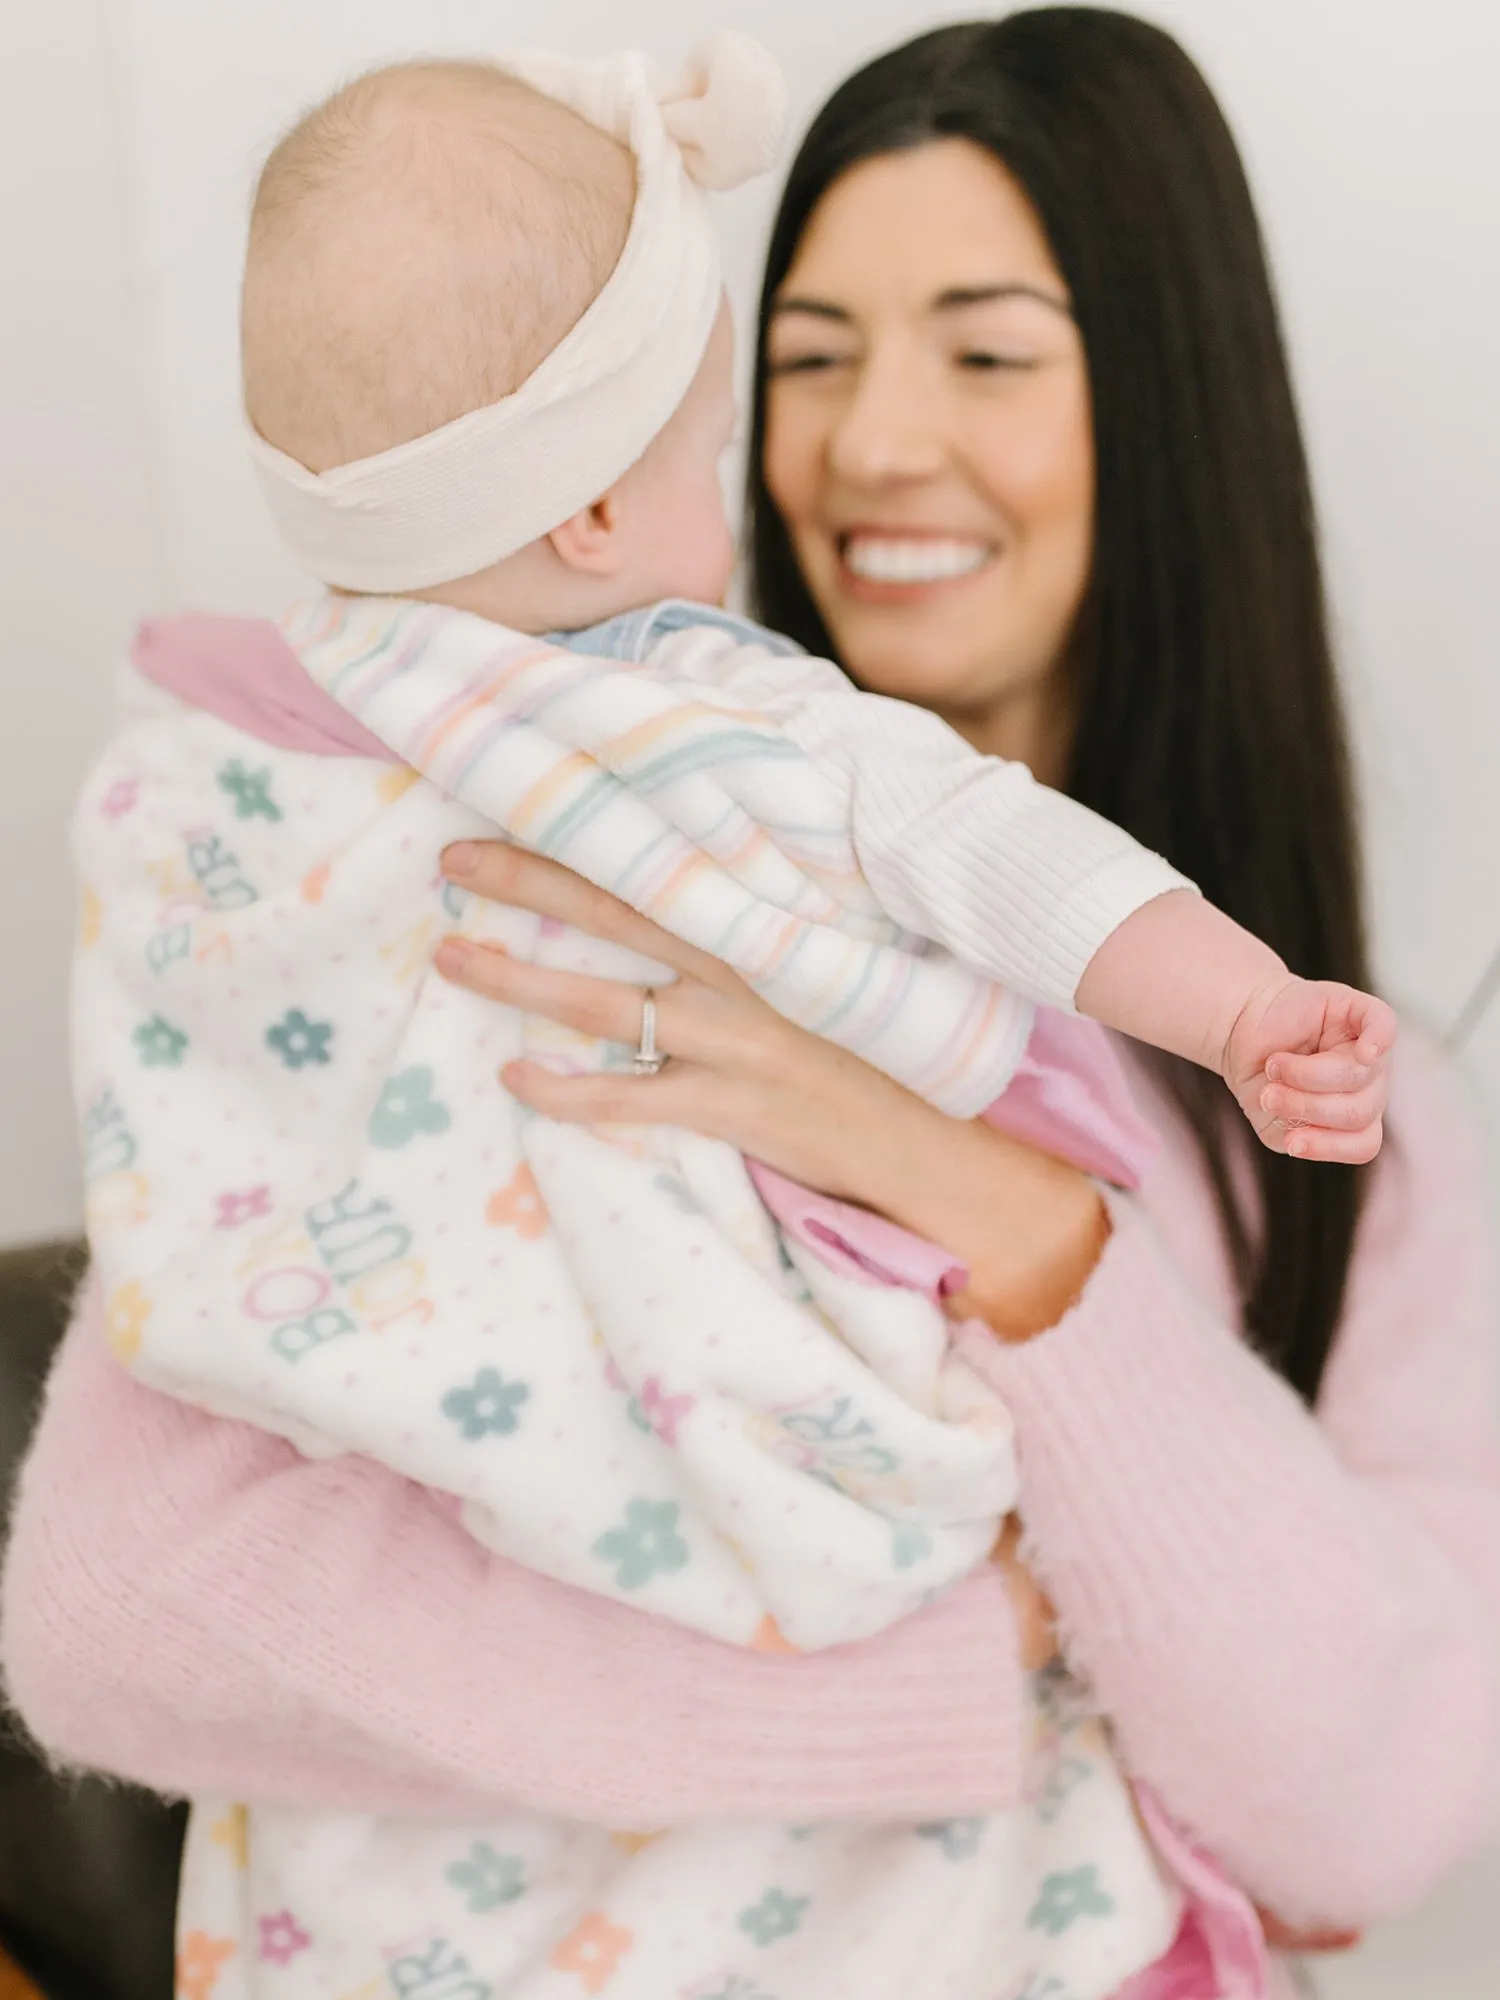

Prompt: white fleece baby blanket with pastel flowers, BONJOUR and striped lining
[{"left": 76, "top": 600, "right": 1224, "bottom": 2000}]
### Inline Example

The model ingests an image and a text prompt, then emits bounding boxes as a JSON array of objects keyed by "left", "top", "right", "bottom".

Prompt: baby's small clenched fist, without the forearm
[{"left": 1224, "top": 974, "right": 1396, "bottom": 1166}]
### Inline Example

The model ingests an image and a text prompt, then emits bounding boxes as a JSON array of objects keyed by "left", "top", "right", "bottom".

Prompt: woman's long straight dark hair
[{"left": 748, "top": 6, "right": 1368, "bottom": 1400}]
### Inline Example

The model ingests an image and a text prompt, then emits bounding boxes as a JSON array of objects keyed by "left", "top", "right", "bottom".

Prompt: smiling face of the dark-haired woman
[{"left": 764, "top": 140, "right": 1094, "bottom": 776}]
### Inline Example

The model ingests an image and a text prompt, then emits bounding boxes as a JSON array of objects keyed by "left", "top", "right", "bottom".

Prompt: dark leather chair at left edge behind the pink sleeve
[{"left": 0, "top": 1244, "right": 186, "bottom": 2000}]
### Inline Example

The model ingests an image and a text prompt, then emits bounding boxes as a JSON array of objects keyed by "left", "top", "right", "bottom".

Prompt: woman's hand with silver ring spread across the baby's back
[{"left": 436, "top": 842, "right": 1108, "bottom": 1338}]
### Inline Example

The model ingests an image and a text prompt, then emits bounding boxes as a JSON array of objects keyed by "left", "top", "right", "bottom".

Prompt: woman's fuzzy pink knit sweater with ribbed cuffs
[{"left": 0, "top": 1044, "right": 1500, "bottom": 1926}]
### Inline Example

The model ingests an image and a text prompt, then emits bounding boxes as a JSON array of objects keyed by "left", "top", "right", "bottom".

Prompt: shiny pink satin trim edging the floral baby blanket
[{"left": 130, "top": 612, "right": 1270, "bottom": 2000}]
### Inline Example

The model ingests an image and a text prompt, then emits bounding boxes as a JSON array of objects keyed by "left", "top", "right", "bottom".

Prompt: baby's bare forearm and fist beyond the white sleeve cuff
[{"left": 1076, "top": 892, "right": 1396, "bottom": 1164}]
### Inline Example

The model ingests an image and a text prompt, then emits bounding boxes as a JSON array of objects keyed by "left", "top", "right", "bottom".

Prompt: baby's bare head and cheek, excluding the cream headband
[{"left": 242, "top": 62, "right": 748, "bottom": 630}]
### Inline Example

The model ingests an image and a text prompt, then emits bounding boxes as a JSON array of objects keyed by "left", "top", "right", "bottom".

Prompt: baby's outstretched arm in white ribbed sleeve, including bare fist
[{"left": 764, "top": 694, "right": 1396, "bottom": 1162}]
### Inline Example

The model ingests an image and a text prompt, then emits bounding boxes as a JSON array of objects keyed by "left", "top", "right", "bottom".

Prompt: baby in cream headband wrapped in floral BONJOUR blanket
[{"left": 76, "top": 36, "right": 1392, "bottom": 2000}]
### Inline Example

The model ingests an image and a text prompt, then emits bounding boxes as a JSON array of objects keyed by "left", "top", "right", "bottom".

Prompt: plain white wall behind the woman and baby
[{"left": 0, "top": 0, "right": 1500, "bottom": 2000}]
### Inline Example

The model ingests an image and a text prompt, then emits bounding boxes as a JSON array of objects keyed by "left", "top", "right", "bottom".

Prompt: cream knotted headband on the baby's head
[{"left": 250, "top": 34, "right": 786, "bottom": 594}]
